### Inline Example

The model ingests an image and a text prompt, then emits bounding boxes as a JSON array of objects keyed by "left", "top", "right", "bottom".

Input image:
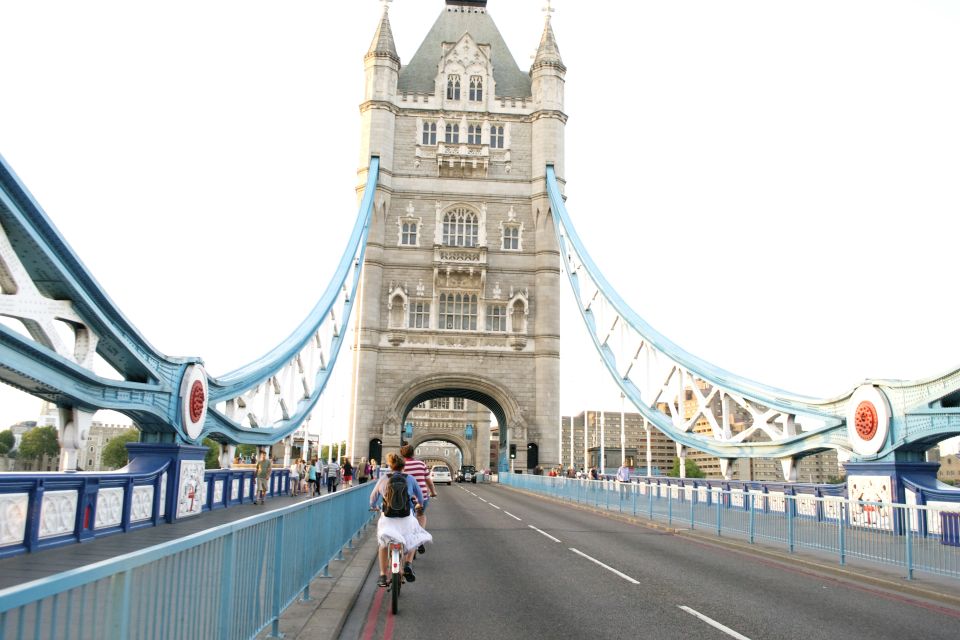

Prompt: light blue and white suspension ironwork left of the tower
[{"left": 0, "top": 157, "right": 379, "bottom": 445}]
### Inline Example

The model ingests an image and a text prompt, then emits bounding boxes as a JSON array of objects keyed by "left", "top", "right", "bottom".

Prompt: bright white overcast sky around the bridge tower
[{"left": 0, "top": 0, "right": 960, "bottom": 450}]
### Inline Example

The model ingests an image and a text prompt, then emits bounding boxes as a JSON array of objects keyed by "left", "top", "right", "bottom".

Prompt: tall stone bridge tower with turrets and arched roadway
[{"left": 350, "top": 0, "right": 566, "bottom": 470}]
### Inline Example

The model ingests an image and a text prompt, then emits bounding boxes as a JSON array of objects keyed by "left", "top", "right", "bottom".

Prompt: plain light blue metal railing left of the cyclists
[{"left": 0, "top": 487, "right": 371, "bottom": 640}]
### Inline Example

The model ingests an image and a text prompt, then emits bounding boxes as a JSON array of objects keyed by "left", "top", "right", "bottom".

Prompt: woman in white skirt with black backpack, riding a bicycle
[{"left": 370, "top": 453, "right": 433, "bottom": 587}]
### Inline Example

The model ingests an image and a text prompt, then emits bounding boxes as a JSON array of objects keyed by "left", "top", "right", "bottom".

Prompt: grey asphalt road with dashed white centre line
[{"left": 341, "top": 484, "right": 960, "bottom": 640}]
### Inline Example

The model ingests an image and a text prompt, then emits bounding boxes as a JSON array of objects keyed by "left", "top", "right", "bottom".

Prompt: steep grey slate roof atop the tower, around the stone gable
[{"left": 398, "top": 6, "right": 533, "bottom": 98}]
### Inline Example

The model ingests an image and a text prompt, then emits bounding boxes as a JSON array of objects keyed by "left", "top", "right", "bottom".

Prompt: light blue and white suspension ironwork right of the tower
[{"left": 546, "top": 165, "right": 960, "bottom": 464}]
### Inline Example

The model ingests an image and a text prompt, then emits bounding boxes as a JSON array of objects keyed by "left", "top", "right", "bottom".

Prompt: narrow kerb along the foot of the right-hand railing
[{"left": 500, "top": 484, "right": 960, "bottom": 607}]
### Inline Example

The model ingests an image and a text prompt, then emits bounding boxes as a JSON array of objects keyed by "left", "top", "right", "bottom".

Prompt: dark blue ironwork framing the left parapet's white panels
[{"left": 0, "top": 462, "right": 290, "bottom": 558}]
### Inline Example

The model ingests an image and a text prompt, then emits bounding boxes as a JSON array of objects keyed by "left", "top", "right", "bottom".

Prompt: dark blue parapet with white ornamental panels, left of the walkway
[{"left": 0, "top": 463, "right": 290, "bottom": 560}]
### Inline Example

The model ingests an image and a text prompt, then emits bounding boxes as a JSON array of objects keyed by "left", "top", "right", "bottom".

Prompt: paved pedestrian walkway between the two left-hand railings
[{"left": 0, "top": 496, "right": 306, "bottom": 589}]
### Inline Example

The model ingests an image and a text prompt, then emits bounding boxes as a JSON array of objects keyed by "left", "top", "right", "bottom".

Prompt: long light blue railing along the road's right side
[{"left": 500, "top": 473, "right": 960, "bottom": 579}]
